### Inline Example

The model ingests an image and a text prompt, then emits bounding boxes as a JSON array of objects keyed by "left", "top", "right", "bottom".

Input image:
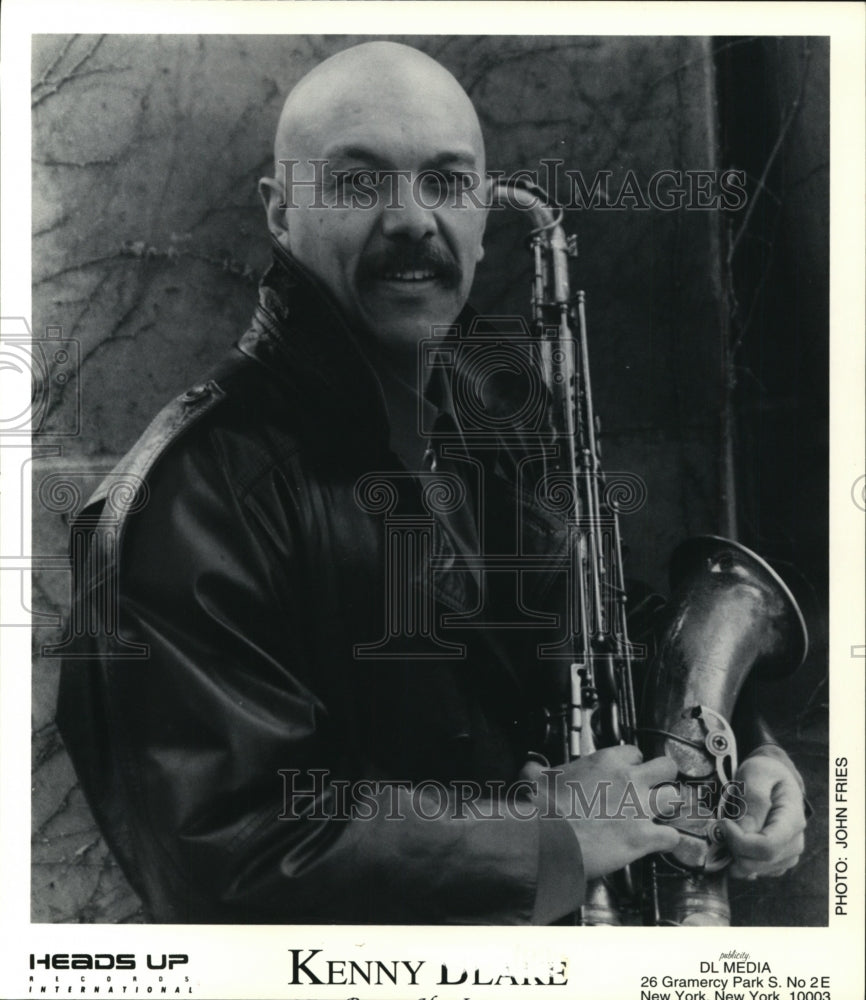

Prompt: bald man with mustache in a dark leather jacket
[{"left": 58, "top": 42, "right": 804, "bottom": 923}]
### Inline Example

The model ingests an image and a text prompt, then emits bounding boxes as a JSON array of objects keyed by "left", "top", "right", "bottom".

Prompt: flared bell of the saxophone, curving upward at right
[{"left": 639, "top": 535, "right": 809, "bottom": 872}]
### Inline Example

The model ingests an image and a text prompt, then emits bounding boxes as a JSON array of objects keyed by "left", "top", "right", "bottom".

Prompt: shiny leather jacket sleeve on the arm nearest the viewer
[{"left": 64, "top": 426, "right": 583, "bottom": 923}]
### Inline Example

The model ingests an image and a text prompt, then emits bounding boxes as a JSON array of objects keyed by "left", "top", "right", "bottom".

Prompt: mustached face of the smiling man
[{"left": 277, "top": 72, "right": 486, "bottom": 350}]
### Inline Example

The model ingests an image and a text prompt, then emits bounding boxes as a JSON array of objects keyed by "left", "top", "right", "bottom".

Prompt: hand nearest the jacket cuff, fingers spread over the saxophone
[{"left": 522, "top": 746, "right": 680, "bottom": 879}]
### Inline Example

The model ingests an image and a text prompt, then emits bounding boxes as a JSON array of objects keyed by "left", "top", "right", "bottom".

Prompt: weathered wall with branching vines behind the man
[{"left": 31, "top": 36, "right": 828, "bottom": 923}]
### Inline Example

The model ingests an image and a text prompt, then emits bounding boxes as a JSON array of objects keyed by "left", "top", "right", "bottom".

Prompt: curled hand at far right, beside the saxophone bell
[{"left": 722, "top": 754, "right": 806, "bottom": 879}]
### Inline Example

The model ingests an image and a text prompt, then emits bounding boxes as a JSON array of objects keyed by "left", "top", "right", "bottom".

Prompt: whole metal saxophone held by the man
[{"left": 496, "top": 182, "right": 808, "bottom": 926}]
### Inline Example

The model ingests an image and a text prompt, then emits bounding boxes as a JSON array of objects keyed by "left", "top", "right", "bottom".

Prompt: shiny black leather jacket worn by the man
[{"left": 58, "top": 242, "right": 788, "bottom": 923}]
